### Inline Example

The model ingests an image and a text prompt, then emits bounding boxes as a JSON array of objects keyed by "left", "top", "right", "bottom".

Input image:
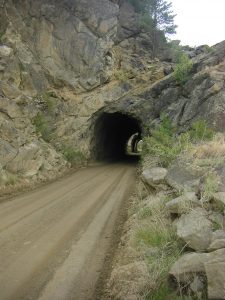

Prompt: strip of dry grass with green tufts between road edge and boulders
[{"left": 133, "top": 194, "right": 182, "bottom": 300}]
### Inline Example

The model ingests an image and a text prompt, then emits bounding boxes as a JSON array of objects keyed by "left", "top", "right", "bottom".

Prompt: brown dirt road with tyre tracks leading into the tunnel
[{"left": 0, "top": 164, "right": 135, "bottom": 300}]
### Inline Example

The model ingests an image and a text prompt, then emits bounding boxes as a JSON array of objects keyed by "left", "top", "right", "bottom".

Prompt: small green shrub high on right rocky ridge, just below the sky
[{"left": 174, "top": 53, "right": 193, "bottom": 84}]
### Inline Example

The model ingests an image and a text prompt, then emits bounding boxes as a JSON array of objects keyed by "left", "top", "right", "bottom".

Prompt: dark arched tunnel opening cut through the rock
[{"left": 92, "top": 112, "right": 141, "bottom": 161}]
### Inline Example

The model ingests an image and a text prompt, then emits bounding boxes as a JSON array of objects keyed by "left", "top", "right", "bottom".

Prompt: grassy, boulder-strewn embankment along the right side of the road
[{"left": 106, "top": 132, "right": 225, "bottom": 300}]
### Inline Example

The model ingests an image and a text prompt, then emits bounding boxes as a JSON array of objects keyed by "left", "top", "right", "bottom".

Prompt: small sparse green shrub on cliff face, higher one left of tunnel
[{"left": 33, "top": 112, "right": 52, "bottom": 142}]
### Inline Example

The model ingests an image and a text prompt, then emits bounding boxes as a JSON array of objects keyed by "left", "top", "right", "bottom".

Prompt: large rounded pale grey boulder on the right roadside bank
[{"left": 176, "top": 208, "right": 213, "bottom": 251}]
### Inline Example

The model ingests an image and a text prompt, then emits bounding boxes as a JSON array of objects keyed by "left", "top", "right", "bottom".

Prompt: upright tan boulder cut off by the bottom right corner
[{"left": 204, "top": 249, "right": 225, "bottom": 299}]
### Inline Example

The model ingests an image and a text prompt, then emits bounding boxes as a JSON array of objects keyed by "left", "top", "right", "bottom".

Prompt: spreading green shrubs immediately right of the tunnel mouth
[{"left": 142, "top": 116, "right": 214, "bottom": 167}]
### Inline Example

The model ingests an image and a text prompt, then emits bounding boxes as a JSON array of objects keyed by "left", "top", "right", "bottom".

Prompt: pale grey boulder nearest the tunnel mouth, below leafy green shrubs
[{"left": 142, "top": 168, "right": 167, "bottom": 189}]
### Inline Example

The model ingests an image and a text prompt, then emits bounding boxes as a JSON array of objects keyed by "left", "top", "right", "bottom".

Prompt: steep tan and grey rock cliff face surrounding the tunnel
[{"left": 0, "top": 0, "right": 225, "bottom": 188}]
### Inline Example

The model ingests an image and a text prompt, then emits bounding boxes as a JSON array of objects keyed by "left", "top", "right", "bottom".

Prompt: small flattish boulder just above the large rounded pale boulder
[{"left": 166, "top": 192, "right": 201, "bottom": 214}]
